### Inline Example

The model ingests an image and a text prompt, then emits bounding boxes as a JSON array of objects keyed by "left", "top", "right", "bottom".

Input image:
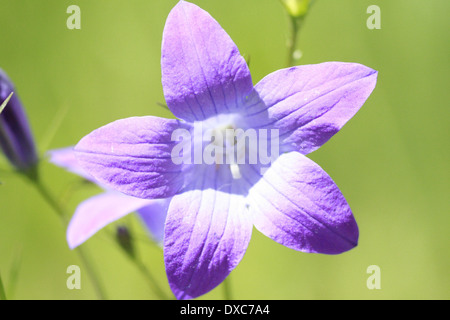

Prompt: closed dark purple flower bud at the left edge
[{"left": 0, "top": 69, "right": 38, "bottom": 170}]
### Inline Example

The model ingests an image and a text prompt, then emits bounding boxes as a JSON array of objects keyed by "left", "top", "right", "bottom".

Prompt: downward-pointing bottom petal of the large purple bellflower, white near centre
[{"left": 164, "top": 166, "right": 252, "bottom": 299}]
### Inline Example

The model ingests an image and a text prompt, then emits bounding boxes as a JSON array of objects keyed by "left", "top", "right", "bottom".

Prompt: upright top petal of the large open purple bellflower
[{"left": 161, "top": 1, "right": 253, "bottom": 122}]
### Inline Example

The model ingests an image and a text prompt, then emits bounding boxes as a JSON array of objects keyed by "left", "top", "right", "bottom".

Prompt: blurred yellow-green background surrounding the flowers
[{"left": 0, "top": 0, "right": 450, "bottom": 299}]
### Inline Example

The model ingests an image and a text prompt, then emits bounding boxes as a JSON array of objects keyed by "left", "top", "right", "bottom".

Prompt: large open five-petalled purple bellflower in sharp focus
[{"left": 75, "top": 1, "right": 377, "bottom": 299}]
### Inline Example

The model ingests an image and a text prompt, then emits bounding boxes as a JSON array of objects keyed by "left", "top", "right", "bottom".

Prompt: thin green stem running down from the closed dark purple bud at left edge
[{"left": 22, "top": 164, "right": 106, "bottom": 300}]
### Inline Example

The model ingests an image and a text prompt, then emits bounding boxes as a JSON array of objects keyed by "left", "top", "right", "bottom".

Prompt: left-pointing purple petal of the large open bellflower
[{"left": 75, "top": 116, "right": 187, "bottom": 199}]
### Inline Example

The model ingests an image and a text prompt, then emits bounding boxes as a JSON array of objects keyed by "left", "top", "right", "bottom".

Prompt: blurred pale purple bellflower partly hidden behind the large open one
[{"left": 48, "top": 147, "right": 170, "bottom": 249}]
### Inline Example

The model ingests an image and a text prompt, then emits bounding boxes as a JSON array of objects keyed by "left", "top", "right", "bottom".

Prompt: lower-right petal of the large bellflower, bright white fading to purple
[{"left": 243, "top": 152, "right": 358, "bottom": 254}]
